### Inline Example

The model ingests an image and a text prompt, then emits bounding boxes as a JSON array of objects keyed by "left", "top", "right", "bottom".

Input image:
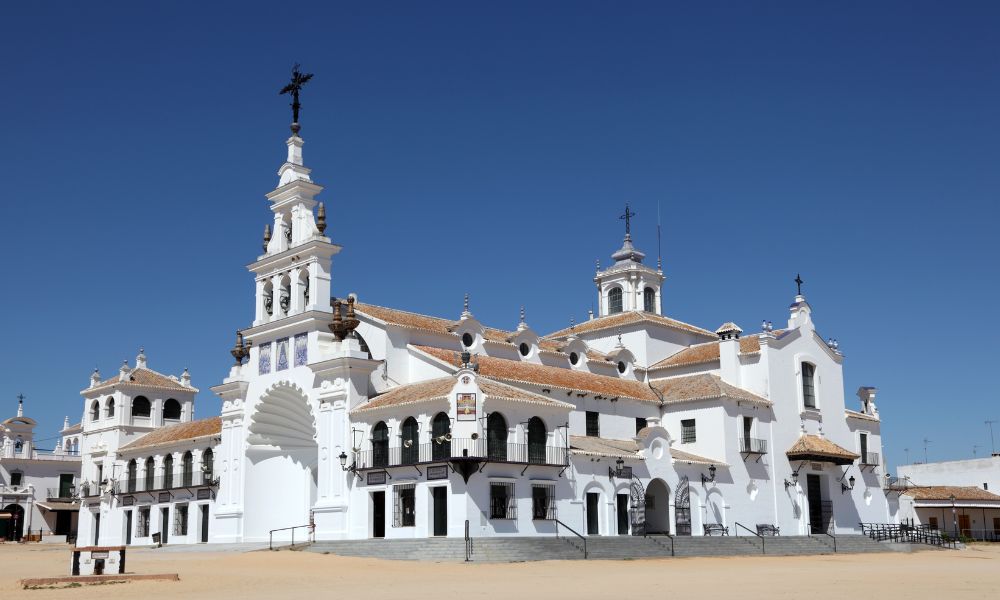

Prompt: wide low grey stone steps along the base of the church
[{"left": 302, "top": 535, "right": 896, "bottom": 562}]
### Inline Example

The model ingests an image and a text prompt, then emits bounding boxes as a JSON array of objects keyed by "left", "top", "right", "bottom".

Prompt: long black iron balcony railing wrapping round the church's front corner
[{"left": 354, "top": 438, "right": 568, "bottom": 470}]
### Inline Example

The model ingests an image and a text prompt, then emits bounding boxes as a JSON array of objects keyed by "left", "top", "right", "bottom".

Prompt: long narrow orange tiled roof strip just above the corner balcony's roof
[{"left": 414, "top": 346, "right": 659, "bottom": 403}]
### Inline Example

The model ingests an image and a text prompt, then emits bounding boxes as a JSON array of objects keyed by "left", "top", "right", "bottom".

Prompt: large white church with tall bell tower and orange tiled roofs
[{"left": 81, "top": 105, "right": 895, "bottom": 544}]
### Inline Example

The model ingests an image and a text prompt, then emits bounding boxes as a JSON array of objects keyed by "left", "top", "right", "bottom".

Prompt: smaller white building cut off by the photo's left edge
[{"left": 0, "top": 397, "right": 80, "bottom": 542}]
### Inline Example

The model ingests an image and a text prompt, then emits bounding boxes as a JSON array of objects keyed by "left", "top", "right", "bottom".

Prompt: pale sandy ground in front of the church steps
[{"left": 0, "top": 544, "right": 1000, "bottom": 600}]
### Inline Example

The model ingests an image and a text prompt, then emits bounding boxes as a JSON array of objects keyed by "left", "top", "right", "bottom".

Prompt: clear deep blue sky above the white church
[{"left": 0, "top": 1, "right": 1000, "bottom": 463}]
